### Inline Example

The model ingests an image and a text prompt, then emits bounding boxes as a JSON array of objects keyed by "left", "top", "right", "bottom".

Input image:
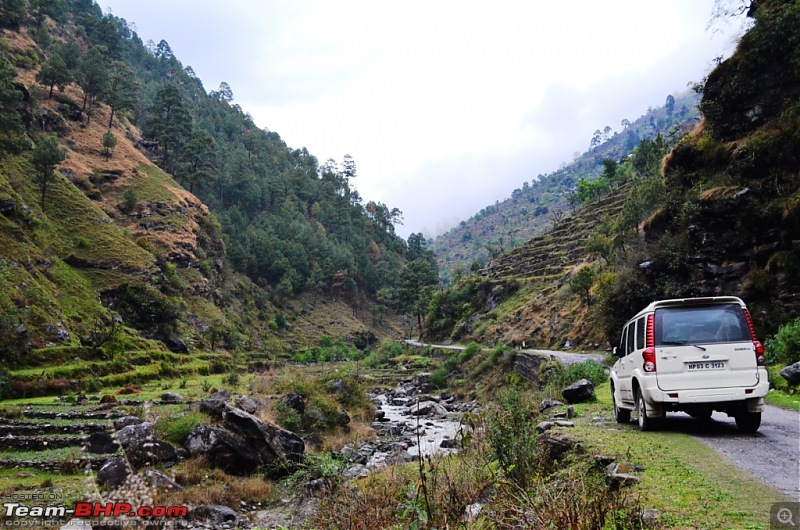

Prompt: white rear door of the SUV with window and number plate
[{"left": 655, "top": 303, "right": 758, "bottom": 390}]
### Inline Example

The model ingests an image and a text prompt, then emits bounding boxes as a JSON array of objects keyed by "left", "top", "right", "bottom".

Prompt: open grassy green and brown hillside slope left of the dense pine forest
[{"left": 0, "top": 10, "right": 403, "bottom": 376}]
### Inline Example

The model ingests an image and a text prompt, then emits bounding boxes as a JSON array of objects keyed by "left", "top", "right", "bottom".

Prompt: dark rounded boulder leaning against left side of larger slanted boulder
[{"left": 184, "top": 423, "right": 263, "bottom": 475}]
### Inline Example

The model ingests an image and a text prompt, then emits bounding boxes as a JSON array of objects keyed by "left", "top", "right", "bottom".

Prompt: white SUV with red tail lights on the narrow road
[{"left": 611, "top": 296, "right": 769, "bottom": 432}]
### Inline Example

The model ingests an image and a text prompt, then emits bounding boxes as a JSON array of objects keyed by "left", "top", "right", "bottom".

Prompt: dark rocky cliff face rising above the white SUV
[{"left": 644, "top": 1, "right": 800, "bottom": 333}]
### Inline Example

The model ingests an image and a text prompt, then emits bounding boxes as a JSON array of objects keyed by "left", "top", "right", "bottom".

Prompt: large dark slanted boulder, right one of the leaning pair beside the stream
[{"left": 222, "top": 405, "right": 305, "bottom": 470}]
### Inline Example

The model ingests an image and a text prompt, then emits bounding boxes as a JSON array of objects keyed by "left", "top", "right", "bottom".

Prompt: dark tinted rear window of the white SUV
[{"left": 655, "top": 304, "right": 752, "bottom": 346}]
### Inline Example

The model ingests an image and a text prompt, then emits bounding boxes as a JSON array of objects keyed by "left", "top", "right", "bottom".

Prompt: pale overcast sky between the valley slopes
[{"left": 99, "top": 0, "right": 736, "bottom": 237}]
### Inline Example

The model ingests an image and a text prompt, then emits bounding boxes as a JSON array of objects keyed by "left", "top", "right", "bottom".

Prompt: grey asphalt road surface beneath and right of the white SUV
[{"left": 648, "top": 405, "right": 800, "bottom": 501}]
